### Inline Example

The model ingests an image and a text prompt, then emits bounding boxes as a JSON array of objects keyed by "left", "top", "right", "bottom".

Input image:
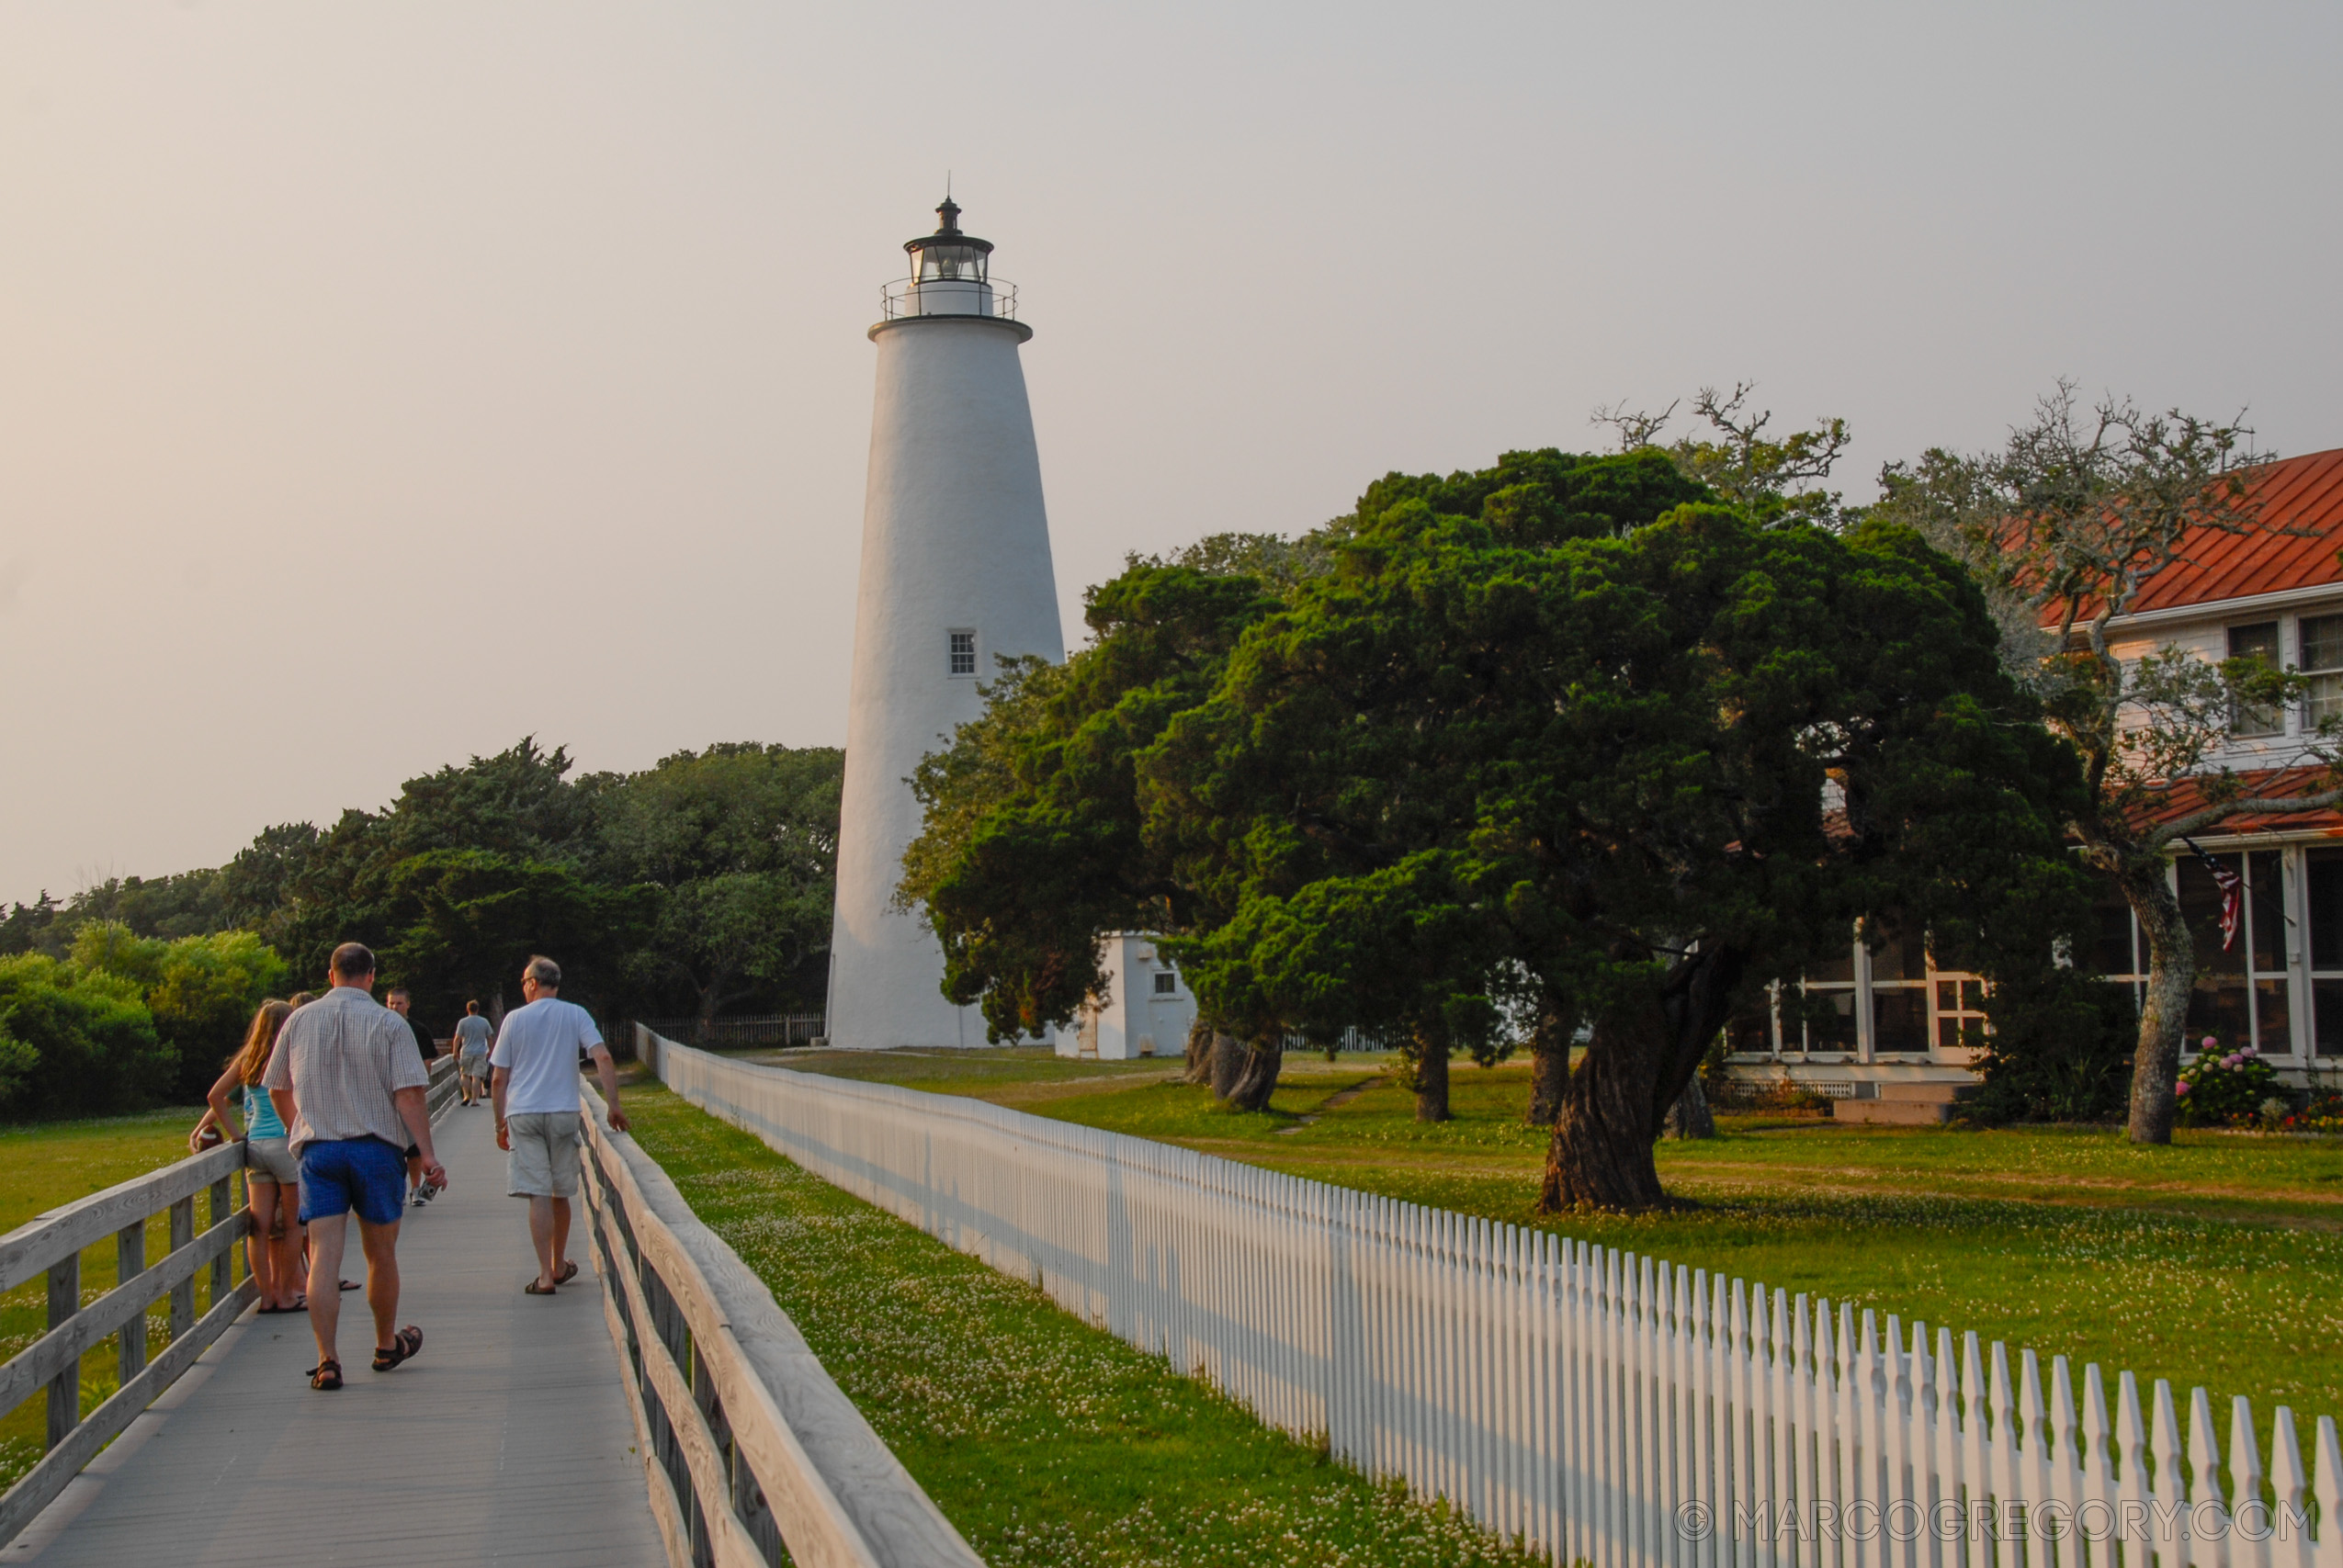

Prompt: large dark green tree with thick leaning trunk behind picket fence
[{"left": 1141, "top": 504, "right": 2080, "bottom": 1210}]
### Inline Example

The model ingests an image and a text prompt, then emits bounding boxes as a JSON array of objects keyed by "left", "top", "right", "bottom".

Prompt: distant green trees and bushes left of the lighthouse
[{"left": 0, "top": 739, "right": 843, "bottom": 1121}]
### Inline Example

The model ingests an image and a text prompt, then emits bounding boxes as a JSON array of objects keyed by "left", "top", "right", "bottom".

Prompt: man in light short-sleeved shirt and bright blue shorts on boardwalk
[{"left": 263, "top": 942, "right": 447, "bottom": 1390}]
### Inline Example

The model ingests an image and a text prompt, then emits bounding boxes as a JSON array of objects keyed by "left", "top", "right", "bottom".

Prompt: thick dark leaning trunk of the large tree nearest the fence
[{"left": 1537, "top": 947, "right": 1743, "bottom": 1214}]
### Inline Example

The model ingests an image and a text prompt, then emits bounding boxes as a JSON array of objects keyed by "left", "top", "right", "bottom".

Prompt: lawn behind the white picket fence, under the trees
[{"left": 744, "top": 1050, "right": 2343, "bottom": 1429}]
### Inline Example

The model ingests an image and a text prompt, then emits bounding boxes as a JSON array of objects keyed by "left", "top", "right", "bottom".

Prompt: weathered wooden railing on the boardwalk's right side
[{"left": 586, "top": 1095, "right": 984, "bottom": 1568}]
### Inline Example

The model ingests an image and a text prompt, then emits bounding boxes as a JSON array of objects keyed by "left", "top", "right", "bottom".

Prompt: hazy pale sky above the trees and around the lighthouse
[{"left": 0, "top": 0, "right": 2343, "bottom": 900}]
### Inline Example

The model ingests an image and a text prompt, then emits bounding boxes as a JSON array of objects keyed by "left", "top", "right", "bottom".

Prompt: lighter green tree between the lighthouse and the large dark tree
[{"left": 898, "top": 450, "right": 1703, "bottom": 1106}]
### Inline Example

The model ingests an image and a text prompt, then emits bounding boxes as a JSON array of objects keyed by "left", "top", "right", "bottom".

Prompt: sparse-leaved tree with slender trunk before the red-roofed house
[{"left": 1872, "top": 384, "right": 2343, "bottom": 1144}]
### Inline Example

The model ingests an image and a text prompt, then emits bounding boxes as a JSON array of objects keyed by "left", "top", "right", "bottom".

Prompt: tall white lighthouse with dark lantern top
[{"left": 830, "top": 197, "right": 1066, "bottom": 1050}]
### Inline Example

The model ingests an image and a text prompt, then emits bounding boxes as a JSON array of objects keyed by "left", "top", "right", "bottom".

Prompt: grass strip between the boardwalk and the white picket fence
[{"left": 626, "top": 1064, "right": 1533, "bottom": 1568}]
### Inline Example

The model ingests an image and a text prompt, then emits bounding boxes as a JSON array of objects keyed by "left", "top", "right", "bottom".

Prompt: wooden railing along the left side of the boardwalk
[{"left": 0, "top": 1057, "right": 457, "bottom": 1547}]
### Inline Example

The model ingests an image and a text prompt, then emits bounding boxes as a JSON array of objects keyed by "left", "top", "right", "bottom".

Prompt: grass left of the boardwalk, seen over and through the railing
[{"left": 0, "top": 1109, "right": 243, "bottom": 1488}]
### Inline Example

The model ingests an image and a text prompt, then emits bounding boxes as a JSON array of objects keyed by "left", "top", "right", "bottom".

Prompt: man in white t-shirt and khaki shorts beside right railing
[{"left": 487, "top": 959, "right": 626, "bottom": 1296}]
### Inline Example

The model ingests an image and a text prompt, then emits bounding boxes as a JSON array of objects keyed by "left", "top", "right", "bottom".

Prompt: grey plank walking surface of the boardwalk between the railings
[{"left": 0, "top": 1106, "right": 665, "bottom": 1568}]
